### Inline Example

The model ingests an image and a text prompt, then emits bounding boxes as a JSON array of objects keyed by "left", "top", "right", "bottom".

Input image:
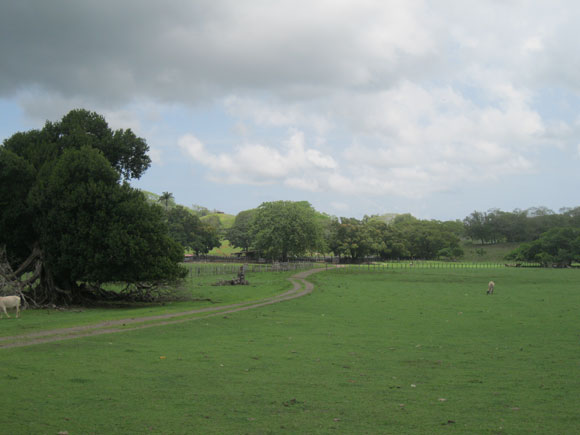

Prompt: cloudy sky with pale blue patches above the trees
[{"left": 0, "top": 0, "right": 580, "bottom": 220}]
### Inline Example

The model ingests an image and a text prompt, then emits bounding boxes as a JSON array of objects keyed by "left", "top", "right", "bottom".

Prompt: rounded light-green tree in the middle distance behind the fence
[{"left": 253, "top": 201, "right": 323, "bottom": 261}]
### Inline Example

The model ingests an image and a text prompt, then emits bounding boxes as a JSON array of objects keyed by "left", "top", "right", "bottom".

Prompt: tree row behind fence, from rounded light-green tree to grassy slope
[{"left": 226, "top": 205, "right": 463, "bottom": 261}]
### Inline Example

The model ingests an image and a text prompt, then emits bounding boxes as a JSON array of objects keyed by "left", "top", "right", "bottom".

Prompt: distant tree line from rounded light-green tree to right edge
[{"left": 224, "top": 201, "right": 580, "bottom": 265}]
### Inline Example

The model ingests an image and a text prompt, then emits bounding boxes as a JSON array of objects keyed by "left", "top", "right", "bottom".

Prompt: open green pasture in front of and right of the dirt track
[{"left": 0, "top": 268, "right": 580, "bottom": 434}]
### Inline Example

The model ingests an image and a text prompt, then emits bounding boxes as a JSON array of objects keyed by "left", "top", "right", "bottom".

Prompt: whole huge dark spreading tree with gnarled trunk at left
[{"left": 0, "top": 110, "right": 183, "bottom": 303}]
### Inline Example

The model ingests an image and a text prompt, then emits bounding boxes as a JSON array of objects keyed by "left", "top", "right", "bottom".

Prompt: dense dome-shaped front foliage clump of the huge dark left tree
[{"left": 29, "top": 146, "right": 183, "bottom": 288}]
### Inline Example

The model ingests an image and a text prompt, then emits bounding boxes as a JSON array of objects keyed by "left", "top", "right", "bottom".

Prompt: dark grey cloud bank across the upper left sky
[{"left": 0, "top": 0, "right": 444, "bottom": 104}]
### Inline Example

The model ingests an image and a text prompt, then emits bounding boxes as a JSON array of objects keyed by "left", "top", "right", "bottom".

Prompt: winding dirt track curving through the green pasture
[{"left": 0, "top": 269, "right": 325, "bottom": 349}]
